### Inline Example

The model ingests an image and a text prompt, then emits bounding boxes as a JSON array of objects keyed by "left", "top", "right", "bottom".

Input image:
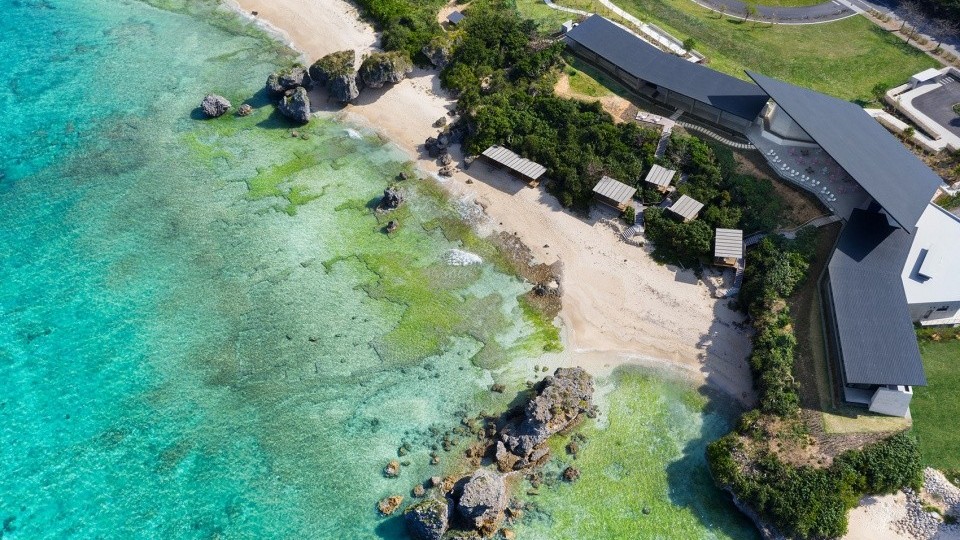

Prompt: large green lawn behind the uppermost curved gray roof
[{"left": 592, "top": 0, "right": 937, "bottom": 100}]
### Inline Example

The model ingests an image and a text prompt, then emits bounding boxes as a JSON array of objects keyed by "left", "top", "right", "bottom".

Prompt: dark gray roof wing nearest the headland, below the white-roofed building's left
[{"left": 829, "top": 209, "right": 927, "bottom": 386}]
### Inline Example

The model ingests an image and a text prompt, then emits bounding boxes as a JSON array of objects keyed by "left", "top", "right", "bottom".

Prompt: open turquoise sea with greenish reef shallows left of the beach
[{"left": 0, "top": 0, "right": 749, "bottom": 539}]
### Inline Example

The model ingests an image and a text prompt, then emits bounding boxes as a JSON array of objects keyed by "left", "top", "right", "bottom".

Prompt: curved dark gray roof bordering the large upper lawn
[{"left": 567, "top": 15, "right": 769, "bottom": 120}]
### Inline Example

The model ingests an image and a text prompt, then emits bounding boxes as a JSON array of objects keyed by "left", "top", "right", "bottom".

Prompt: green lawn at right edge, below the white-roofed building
[{"left": 910, "top": 330, "right": 960, "bottom": 471}]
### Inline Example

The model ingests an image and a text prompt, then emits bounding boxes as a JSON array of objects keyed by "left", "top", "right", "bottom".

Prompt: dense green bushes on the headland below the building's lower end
[{"left": 707, "top": 426, "right": 923, "bottom": 538}]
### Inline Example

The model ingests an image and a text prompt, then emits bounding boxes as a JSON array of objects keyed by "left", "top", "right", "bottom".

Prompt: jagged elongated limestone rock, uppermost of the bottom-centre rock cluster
[{"left": 502, "top": 368, "right": 593, "bottom": 461}]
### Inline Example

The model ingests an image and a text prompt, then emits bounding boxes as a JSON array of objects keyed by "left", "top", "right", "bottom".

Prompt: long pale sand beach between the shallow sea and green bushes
[{"left": 229, "top": 0, "right": 754, "bottom": 404}]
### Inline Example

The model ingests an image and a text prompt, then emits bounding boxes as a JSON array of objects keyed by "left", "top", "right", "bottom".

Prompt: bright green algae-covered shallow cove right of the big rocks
[{"left": 517, "top": 370, "right": 756, "bottom": 539}]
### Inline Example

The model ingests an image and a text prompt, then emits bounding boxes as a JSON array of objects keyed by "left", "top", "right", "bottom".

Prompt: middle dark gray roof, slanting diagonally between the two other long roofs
[{"left": 747, "top": 71, "right": 943, "bottom": 233}]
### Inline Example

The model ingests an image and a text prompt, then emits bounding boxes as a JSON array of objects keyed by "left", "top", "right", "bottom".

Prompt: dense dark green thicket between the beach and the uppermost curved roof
[{"left": 441, "top": 3, "right": 657, "bottom": 209}]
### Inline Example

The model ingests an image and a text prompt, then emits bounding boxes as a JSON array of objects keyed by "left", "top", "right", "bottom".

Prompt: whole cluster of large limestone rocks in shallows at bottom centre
[{"left": 380, "top": 368, "right": 596, "bottom": 540}]
